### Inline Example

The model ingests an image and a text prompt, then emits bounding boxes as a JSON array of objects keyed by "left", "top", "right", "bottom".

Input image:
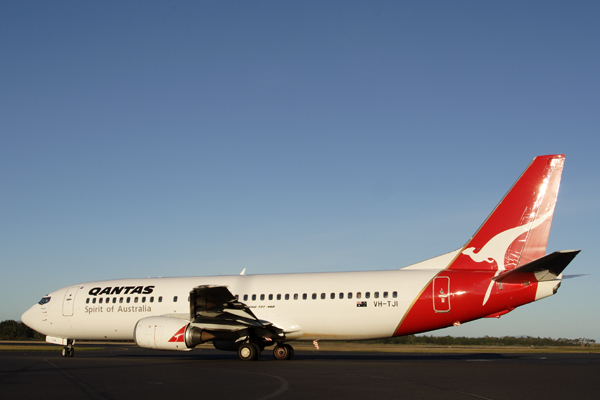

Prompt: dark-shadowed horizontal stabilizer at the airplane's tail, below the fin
[{"left": 494, "top": 250, "right": 581, "bottom": 283}]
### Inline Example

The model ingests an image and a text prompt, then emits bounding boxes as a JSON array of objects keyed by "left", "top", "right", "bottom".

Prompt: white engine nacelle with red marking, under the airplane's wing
[{"left": 133, "top": 317, "right": 193, "bottom": 351}]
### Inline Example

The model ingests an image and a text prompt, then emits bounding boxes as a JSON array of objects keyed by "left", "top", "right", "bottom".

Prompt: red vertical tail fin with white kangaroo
[{"left": 448, "top": 154, "right": 565, "bottom": 273}]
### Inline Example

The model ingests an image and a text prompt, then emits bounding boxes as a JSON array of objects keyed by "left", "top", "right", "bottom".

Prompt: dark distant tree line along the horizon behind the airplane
[{"left": 0, "top": 320, "right": 596, "bottom": 347}]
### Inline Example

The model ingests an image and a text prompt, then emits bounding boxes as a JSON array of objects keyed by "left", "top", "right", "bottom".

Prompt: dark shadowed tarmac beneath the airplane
[{"left": 0, "top": 344, "right": 600, "bottom": 400}]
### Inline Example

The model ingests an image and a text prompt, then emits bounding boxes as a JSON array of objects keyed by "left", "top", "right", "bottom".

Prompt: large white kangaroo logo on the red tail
[{"left": 462, "top": 210, "right": 553, "bottom": 305}]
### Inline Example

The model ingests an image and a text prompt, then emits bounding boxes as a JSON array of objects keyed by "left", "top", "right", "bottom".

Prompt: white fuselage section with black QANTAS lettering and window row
[{"left": 22, "top": 253, "right": 454, "bottom": 340}]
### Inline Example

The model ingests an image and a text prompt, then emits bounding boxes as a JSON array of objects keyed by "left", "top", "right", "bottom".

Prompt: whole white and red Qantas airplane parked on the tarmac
[{"left": 21, "top": 154, "right": 580, "bottom": 361}]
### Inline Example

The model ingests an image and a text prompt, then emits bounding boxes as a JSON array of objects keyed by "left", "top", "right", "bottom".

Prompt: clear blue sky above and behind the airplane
[{"left": 0, "top": 1, "right": 600, "bottom": 342}]
